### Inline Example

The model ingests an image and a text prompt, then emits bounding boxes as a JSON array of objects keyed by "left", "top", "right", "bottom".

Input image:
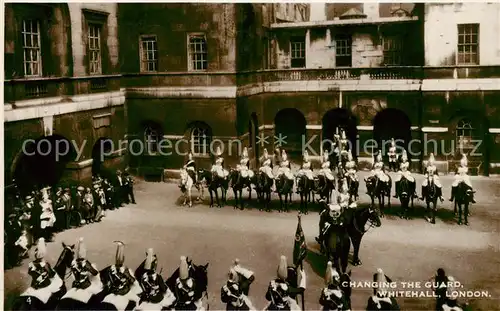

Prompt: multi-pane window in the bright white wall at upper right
[{"left": 457, "top": 24, "right": 479, "bottom": 65}]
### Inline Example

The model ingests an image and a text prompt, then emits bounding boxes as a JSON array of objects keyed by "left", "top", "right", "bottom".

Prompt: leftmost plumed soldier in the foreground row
[{"left": 21, "top": 238, "right": 64, "bottom": 304}]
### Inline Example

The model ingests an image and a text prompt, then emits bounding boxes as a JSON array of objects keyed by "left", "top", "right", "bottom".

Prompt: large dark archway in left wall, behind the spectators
[{"left": 12, "top": 135, "right": 78, "bottom": 193}]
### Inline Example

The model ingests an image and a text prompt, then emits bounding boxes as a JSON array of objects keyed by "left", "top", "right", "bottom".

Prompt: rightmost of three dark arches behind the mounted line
[{"left": 373, "top": 108, "right": 411, "bottom": 156}]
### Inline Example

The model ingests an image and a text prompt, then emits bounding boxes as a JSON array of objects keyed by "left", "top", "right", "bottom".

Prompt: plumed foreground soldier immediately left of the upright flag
[{"left": 265, "top": 256, "right": 305, "bottom": 311}]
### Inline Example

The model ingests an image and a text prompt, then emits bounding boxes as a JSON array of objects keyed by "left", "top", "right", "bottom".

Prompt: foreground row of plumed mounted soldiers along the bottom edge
[{"left": 14, "top": 238, "right": 463, "bottom": 311}]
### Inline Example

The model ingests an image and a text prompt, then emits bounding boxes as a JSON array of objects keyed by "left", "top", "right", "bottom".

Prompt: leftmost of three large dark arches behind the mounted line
[{"left": 274, "top": 108, "right": 306, "bottom": 157}]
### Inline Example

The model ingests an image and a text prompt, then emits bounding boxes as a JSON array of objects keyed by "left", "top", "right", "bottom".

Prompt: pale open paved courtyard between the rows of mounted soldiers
[{"left": 4, "top": 173, "right": 500, "bottom": 311}]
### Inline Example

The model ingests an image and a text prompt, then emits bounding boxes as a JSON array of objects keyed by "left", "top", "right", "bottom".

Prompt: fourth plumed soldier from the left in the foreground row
[{"left": 135, "top": 248, "right": 175, "bottom": 311}]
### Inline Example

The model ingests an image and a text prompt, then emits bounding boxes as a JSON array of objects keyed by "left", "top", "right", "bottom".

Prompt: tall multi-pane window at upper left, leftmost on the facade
[{"left": 23, "top": 20, "right": 42, "bottom": 77}]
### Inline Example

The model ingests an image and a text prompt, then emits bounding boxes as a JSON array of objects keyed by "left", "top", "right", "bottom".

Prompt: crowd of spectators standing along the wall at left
[{"left": 4, "top": 170, "right": 135, "bottom": 266}]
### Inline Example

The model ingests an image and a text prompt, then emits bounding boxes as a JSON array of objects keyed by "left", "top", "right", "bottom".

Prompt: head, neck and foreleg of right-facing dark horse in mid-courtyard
[{"left": 344, "top": 206, "right": 382, "bottom": 266}]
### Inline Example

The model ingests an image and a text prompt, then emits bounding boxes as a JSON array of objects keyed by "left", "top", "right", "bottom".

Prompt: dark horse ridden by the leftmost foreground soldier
[{"left": 12, "top": 242, "right": 75, "bottom": 310}]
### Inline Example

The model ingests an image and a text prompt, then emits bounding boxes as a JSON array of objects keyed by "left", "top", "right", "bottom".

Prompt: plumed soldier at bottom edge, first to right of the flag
[{"left": 319, "top": 261, "right": 349, "bottom": 310}]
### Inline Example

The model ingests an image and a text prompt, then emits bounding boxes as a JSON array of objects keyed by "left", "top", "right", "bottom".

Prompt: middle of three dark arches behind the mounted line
[{"left": 322, "top": 108, "right": 358, "bottom": 157}]
